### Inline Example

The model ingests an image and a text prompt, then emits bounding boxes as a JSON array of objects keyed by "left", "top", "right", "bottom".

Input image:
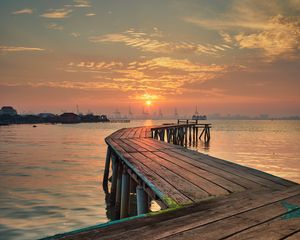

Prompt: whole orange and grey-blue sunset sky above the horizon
[{"left": 0, "top": 0, "right": 300, "bottom": 116}]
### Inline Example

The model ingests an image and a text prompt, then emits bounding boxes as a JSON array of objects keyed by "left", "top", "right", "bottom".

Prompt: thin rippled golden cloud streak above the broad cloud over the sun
[{"left": 89, "top": 28, "right": 225, "bottom": 55}]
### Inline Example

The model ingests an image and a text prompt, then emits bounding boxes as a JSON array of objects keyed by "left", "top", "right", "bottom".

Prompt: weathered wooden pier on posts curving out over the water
[{"left": 49, "top": 121, "right": 300, "bottom": 240}]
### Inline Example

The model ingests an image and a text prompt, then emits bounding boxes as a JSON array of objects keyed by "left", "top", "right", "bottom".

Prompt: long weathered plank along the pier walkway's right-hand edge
[{"left": 171, "top": 149, "right": 285, "bottom": 189}]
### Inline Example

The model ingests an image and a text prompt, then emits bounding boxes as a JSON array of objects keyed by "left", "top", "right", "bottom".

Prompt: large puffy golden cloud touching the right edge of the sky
[{"left": 234, "top": 15, "right": 300, "bottom": 61}]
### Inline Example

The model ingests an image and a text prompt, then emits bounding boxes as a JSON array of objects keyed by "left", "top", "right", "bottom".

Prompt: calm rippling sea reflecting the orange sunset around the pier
[{"left": 0, "top": 120, "right": 300, "bottom": 240}]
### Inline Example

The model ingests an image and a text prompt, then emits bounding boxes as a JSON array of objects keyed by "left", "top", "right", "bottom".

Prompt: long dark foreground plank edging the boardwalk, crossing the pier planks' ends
[{"left": 54, "top": 185, "right": 300, "bottom": 240}]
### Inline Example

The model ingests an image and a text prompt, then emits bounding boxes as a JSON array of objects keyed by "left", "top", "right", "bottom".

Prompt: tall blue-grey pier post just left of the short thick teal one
[{"left": 120, "top": 168, "right": 130, "bottom": 219}]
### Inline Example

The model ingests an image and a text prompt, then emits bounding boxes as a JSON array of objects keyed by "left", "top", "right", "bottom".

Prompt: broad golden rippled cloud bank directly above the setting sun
[{"left": 66, "top": 57, "right": 241, "bottom": 96}]
